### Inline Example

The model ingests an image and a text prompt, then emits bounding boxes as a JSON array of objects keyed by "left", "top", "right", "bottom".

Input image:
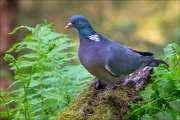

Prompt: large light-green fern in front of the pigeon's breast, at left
[{"left": 0, "top": 23, "right": 90, "bottom": 120}]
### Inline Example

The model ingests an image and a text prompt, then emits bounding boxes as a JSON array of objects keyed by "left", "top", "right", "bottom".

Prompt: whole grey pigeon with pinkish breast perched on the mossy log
[{"left": 65, "top": 15, "right": 166, "bottom": 89}]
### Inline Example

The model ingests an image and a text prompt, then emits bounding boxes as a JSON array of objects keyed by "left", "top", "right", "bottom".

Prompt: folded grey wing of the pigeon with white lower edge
[{"left": 104, "top": 42, "right": 142, "bottom": 76}]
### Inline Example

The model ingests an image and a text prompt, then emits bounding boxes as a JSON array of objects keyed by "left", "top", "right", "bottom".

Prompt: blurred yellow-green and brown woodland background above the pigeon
[{"left": 18, "top": 0, "right": 180, "bottom": 55}]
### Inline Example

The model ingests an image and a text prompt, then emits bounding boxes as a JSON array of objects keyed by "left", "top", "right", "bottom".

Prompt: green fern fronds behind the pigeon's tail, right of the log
[{"left": 124, "top": 43, "right": 180, "bottom": 120}]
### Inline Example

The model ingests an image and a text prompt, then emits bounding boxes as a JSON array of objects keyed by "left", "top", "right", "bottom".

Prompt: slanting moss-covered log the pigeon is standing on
[{"left": 57, "top": 67, "right": 153, "bottom": 120}]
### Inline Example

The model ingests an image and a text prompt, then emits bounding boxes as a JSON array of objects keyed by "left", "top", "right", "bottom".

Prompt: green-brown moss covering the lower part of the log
[{"left": 57, "top": 87, "right": 129, "bottom": 120}]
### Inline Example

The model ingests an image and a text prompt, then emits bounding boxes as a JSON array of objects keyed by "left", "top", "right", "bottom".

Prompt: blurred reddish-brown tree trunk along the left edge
[{"left": 0, "top": 0, "right": 18, "bottom": 88}]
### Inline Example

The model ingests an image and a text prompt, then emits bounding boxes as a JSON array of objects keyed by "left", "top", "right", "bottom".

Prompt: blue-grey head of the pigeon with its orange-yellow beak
[{"left": 65, "top": 15, "right": 92, "bottom": 31}]
